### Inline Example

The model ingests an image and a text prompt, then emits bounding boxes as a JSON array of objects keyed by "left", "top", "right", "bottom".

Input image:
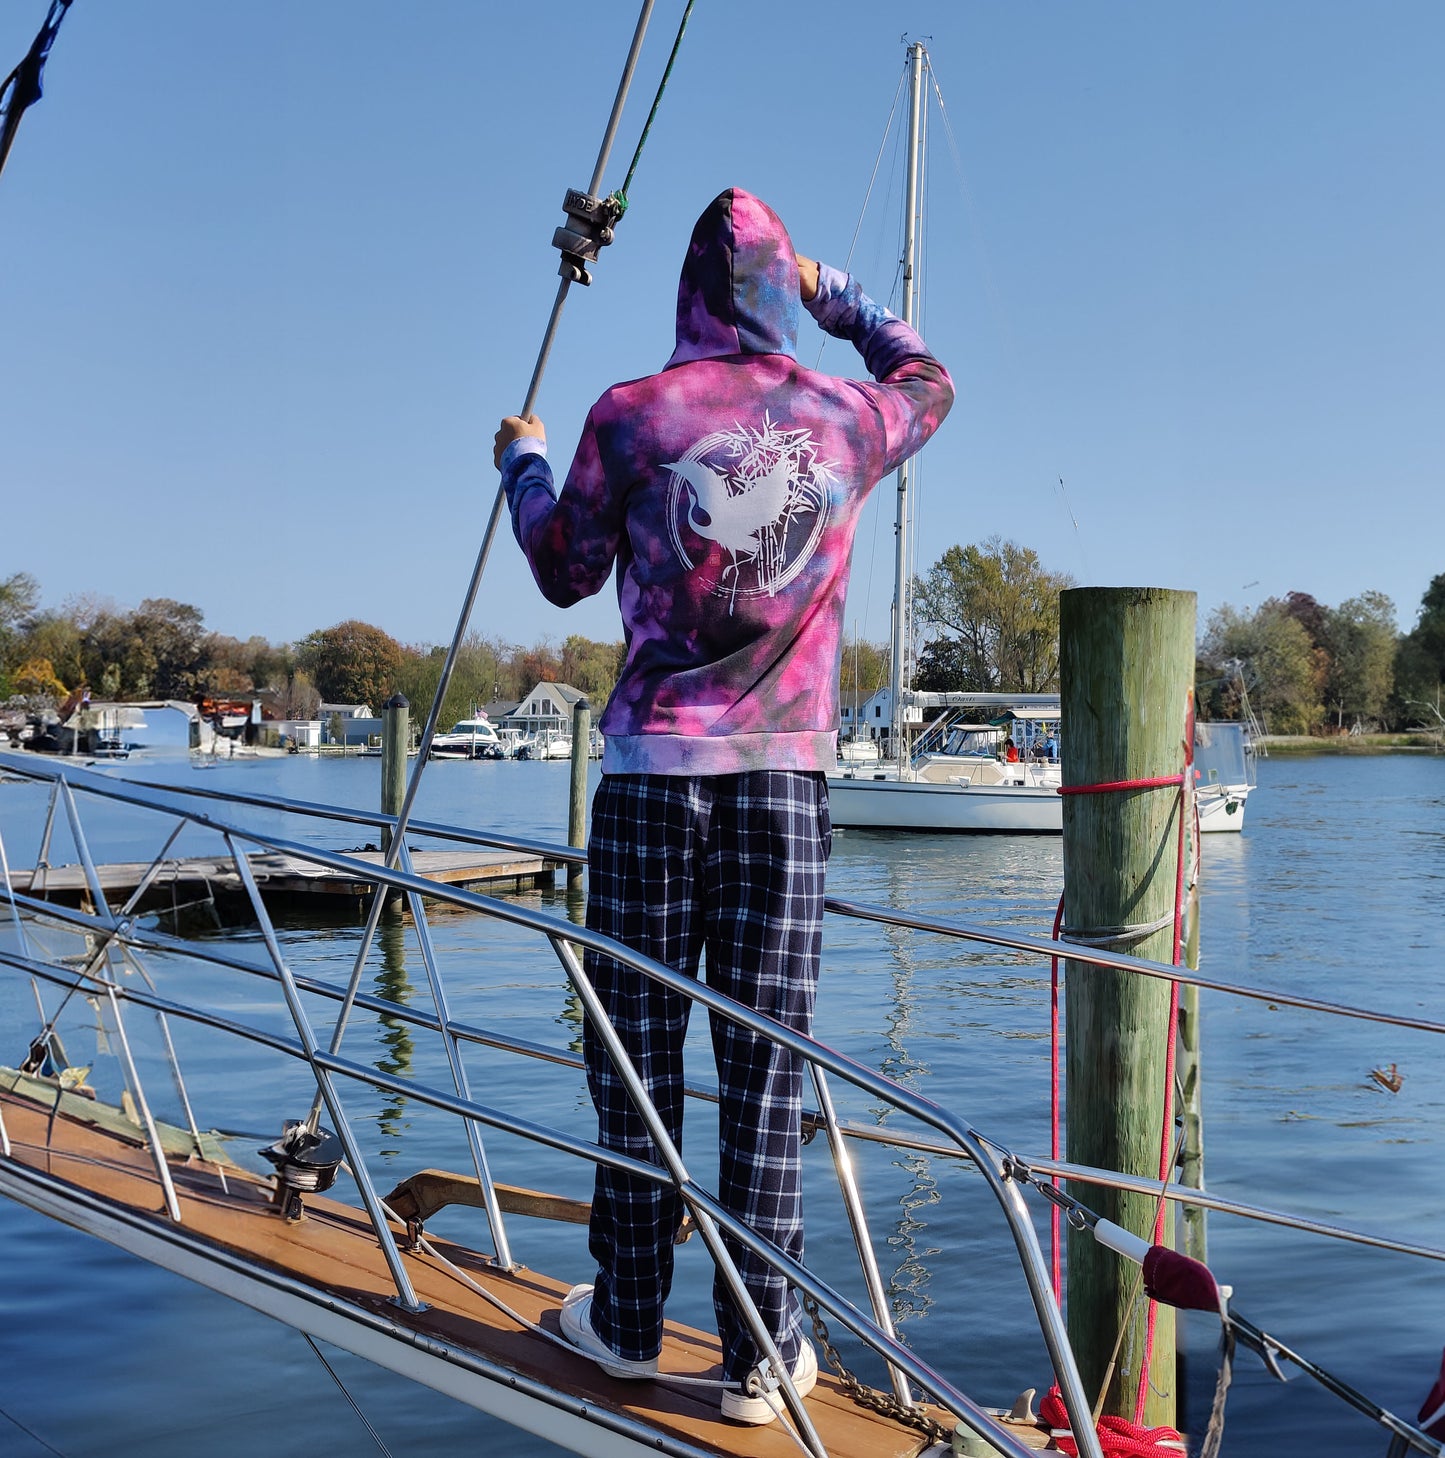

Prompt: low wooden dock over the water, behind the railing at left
[{"left": 10, "top": 850, "right": 557, "bottom": 911}]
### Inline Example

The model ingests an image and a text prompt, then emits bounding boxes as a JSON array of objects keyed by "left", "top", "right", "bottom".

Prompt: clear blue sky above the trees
[{"left": 0, "top": 0, "right": 1445, "bottom": 643}]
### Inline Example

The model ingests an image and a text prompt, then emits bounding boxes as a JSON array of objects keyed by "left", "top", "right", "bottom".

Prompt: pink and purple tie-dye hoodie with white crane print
[{"left": 502, "top": 188, "right": 954, "bottom": 774}]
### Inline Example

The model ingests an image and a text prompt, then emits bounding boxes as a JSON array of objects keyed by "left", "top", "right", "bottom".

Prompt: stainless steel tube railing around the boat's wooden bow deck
[{"left": 0, "top": 754, "right": 1445, "bottom": 1458}]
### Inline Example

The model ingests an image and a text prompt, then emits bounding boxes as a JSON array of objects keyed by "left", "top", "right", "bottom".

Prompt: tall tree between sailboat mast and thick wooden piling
[{"left": 913, "top": 535, "right": 1073, "bottom": 694}]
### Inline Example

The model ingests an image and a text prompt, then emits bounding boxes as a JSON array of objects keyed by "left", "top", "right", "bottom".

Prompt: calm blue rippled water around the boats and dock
[{"left": 0, "top": 757, "right": 1445, "bottom": 1458}]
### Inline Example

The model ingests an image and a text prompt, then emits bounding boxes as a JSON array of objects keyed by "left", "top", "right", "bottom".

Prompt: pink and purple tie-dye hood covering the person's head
[{"left": 668, "top": 187, "right": 799, "bottom": 367}]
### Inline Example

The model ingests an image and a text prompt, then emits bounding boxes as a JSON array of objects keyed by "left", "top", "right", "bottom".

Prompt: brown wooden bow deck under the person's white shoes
[{"left": 0, "top": 1070, "right": 1047, "bottom": 1458}]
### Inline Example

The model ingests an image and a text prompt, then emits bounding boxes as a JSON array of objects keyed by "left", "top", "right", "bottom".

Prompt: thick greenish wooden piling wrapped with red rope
[{"left": 1060, "top": 588, "right": 1194, "bottom": 1424}]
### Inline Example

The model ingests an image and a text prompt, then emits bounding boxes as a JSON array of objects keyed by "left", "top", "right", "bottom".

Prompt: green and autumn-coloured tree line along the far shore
[{"left": 0, "top": 559, "right": 1445, "bottom": 733}]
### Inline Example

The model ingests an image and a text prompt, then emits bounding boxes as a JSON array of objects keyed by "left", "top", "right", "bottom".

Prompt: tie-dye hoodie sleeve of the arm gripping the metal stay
[{"left": 502, "top": 414, "right": 623, "bottom": 608}]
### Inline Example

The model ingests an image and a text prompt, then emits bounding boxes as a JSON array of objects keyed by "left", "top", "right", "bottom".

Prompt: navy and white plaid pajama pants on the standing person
[{"left": 583, "top": 770, "right": 833, "bottom": 1381}]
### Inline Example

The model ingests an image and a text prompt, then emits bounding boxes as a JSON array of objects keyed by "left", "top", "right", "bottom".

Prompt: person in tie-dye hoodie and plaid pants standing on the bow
[{"left": 496, "top": 188, "right": 954, "bottom": 1423}]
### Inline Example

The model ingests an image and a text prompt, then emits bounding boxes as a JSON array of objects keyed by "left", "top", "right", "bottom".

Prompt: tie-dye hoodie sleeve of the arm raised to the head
[{"left": 803, "top": 264, "right": 954, "bottom": 472}]
